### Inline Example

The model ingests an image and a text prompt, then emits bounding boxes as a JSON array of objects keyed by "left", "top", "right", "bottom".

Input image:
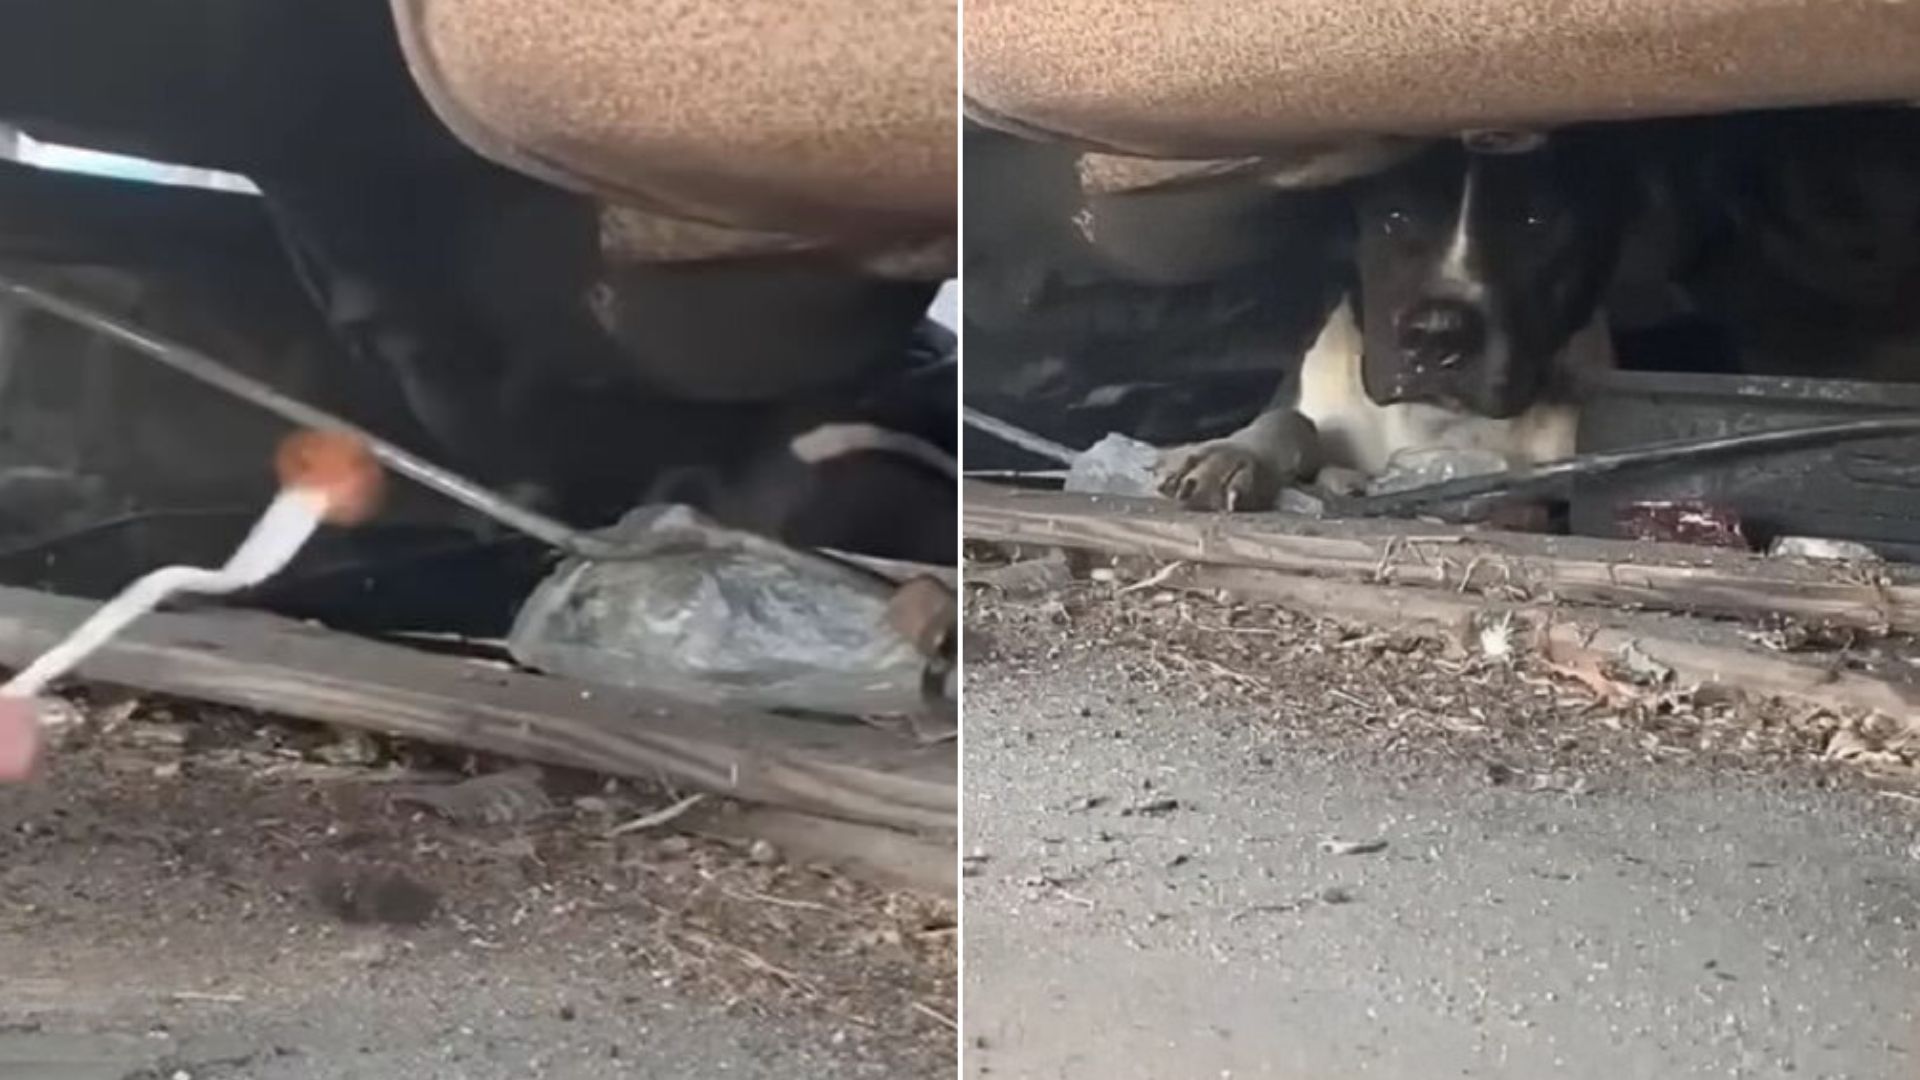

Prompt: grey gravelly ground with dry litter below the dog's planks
[{"left": 964, "top": 575, "right": 1920, "bottom": 1080}]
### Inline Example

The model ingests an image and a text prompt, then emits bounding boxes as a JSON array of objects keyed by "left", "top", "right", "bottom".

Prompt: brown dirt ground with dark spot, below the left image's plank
[{"left": 0, "top": 700, "right": 956, "bottom": 1080}]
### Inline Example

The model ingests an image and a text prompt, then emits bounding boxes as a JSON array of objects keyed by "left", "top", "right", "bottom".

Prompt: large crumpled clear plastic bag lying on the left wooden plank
[{"left": 507, "top": 505, "right": 925, "bottom": 717}]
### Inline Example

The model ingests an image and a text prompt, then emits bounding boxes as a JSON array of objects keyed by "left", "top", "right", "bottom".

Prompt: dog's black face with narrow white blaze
[{"left": 1356, "top": 135, "right": 1630, "bottom": 417}]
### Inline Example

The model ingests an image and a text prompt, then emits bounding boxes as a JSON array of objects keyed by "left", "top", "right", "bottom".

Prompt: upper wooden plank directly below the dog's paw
[{"left": 964, "top": 484, "right": 1920, "bottom": 632}]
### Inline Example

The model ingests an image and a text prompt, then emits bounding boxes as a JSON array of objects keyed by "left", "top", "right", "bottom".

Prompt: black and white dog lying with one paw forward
[{"left": 1162, "top": 129, "right": 1642, "bottom": 509}]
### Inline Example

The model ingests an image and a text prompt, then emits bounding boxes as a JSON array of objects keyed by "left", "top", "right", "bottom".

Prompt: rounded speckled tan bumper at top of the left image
[{"left": 394, "top": 0, "right": 958, "bottom": 258}]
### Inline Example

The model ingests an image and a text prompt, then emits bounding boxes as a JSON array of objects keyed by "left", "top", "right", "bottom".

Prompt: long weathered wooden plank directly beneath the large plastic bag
[{"left": 0, "top": 588, "right": 958, "bottom": 838}]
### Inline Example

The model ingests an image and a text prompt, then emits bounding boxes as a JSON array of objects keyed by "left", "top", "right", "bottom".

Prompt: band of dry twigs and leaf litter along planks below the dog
[{"left": 968, "top": 568, "right": 1896, "bottom": 787}]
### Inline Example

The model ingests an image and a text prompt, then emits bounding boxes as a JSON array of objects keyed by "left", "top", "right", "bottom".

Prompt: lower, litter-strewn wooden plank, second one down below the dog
[{"left": 1165, "top": 567, "right": 1920, "bottom": 723}]
